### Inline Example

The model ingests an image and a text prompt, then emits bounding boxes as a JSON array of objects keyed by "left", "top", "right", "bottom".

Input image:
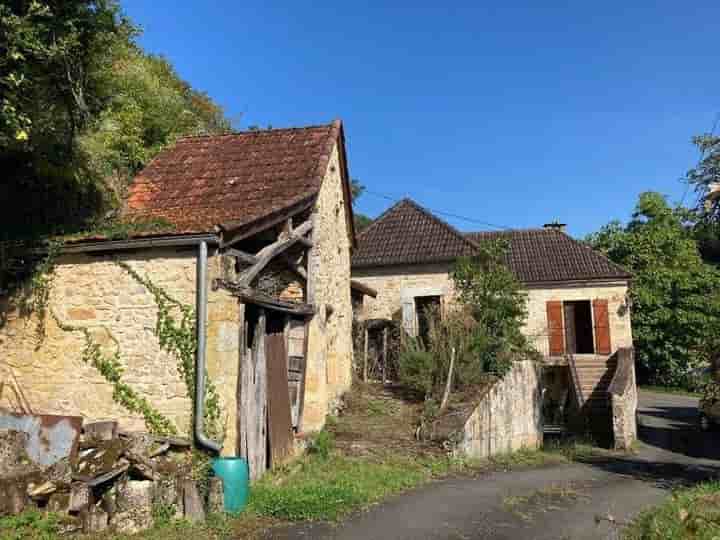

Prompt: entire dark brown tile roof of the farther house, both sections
[{"left": 352, "top": 199, "right": 630, "bottom": 283}]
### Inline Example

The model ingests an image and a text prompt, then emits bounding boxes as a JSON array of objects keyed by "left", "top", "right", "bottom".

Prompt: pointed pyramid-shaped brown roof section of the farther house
[{"left": 352, "top": 199, "right": 477, "bottom": 268}]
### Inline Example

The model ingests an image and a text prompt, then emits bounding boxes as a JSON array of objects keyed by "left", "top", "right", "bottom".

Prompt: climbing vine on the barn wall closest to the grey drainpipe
[{"left": 116, "top": 261, "right": 224, "bottom": 439}]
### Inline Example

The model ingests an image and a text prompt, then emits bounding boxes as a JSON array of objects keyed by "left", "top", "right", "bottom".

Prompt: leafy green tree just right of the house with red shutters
[{"left": 588, "top": 192, "right": 720, "bottom": 387}]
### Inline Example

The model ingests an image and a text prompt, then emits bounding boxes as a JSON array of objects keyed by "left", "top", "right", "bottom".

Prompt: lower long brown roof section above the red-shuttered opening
[{"left": 467, "top": 228, "right": 631, "bottom": 283}]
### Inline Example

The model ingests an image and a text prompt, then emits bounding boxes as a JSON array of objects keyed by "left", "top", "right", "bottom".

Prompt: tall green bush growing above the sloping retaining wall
[{"left": 398, "top": 239, "right": 533, "bottom": 399}]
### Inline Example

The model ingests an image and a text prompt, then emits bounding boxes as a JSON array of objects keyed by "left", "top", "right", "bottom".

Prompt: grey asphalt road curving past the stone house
[{"left": 270, "top": 392, "right": 720, "bottom": 540}]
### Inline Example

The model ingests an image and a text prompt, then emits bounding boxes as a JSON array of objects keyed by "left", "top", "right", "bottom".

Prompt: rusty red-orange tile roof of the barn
[{"left": 126, "top": 120, "right": 342, "bottom": 234}]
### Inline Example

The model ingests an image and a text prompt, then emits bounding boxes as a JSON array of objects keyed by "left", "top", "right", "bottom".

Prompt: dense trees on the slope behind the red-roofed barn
[{"left": 0, "top": 0, "right": 229, "bottom": 240}]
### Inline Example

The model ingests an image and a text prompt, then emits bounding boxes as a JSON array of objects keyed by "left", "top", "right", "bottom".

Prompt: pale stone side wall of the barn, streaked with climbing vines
[{"left": 0, "top": 249, "right": 239, "bottom": 451}]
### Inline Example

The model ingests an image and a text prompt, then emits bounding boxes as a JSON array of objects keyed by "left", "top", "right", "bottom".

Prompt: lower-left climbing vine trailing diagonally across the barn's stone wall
[{"left": 53, "top": 313, "right": 177, "bottom": 435}]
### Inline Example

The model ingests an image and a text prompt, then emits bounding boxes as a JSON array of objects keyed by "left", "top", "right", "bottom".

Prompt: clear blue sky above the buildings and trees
[{"left": 122, "top": 0, "right": 720, "bottom": 236}]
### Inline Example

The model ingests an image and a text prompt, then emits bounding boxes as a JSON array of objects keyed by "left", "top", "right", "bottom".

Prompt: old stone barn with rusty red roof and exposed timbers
[{"left": 0, "top": 121, "right": 355, "bottom": 470}]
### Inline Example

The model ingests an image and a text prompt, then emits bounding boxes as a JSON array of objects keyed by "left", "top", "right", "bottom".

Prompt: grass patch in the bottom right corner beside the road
[{"left": 623, "top": 482, "right": 720, "bottom": 540}]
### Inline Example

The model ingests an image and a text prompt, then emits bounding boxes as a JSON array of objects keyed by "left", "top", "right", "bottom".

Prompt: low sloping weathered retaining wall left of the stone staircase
[{"left": 456, "top": 360, "right": 543, "bottom": 458}]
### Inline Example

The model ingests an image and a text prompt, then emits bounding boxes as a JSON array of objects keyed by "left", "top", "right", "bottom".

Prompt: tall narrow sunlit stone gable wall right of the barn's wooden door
[{"left": 302, "top": 145, "right": 353, "bottom": 431}]
